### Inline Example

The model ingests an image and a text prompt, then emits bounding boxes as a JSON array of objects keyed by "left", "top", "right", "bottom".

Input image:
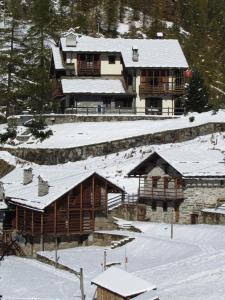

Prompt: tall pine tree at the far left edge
[{"left": 0, "top": 0, "right": 26, "bottom": 112}]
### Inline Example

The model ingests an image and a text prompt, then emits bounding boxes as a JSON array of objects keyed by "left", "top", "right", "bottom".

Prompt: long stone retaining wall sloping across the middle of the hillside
[{"left": 0, "top": 123, "right": 225, "bottom": 165}]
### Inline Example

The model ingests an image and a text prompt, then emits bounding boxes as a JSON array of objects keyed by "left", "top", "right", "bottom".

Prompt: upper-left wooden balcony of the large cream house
[{"left": 77, "top": 60, "right": 101, "bottom": 76}]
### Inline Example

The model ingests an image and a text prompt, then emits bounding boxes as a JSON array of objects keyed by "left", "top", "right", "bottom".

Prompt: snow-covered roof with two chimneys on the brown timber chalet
[{"left": 1, "top": 164, "right": 122, "bottom": 211}]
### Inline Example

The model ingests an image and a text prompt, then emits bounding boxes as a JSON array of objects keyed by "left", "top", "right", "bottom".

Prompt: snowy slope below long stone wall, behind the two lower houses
[{"left": 0, "top": 133, "right": 225, "bottom": 198}]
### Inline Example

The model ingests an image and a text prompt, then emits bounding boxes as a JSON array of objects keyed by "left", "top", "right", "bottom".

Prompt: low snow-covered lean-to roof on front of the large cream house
[{"left": 61, "top": 78, "right": 126, "bottom": 94}]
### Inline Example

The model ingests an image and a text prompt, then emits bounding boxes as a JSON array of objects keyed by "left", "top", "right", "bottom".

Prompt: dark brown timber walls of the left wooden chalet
[{"left": 11, "top": 176, "right": 121, "bottom": 236}]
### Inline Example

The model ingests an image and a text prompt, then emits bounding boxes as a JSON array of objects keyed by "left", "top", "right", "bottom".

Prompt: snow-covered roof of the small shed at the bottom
[{"left": 92, "top": 267, "right": 155, "bottom": 297}]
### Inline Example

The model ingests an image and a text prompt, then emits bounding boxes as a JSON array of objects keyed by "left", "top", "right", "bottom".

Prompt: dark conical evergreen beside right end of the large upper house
[{"left": 186, "top": 70, "right": 209, "bottom": 112}]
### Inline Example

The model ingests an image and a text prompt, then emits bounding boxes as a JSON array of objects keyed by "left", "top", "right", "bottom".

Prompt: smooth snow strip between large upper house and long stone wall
[{"left": 0, "top": 110, "right": 225, "bottom": 148}]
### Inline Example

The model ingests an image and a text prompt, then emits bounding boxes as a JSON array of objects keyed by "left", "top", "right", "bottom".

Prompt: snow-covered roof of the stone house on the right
[{"left": 129, "top": 145, "right": 225, "bottom": 177}]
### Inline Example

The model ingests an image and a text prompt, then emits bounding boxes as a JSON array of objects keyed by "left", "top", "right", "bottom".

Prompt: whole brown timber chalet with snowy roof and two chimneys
[{"left": 3, "top": 169, "right": 124, "bottom": 248}]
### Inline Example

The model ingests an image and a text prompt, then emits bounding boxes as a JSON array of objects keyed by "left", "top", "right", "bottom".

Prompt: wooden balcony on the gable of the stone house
[{"left": 139, "top": 177, "right": 184, "bottom": 201}]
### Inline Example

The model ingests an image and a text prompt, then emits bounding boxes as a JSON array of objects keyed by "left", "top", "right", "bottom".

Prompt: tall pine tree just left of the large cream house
[{"left": 23, "top": 0, "right": 54, "bottom": 113}]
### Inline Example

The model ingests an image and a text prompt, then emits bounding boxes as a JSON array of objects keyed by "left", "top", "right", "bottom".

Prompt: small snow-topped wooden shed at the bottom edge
[{"left": 91, "top": 267, "right": 159, "bottom": 300}]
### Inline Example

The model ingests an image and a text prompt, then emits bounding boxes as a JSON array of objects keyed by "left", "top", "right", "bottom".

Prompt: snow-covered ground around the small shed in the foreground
[{"left": 0, "top": 222, "right": 225, "bottom": 300}]
